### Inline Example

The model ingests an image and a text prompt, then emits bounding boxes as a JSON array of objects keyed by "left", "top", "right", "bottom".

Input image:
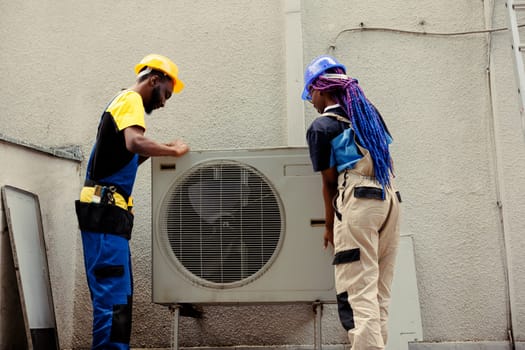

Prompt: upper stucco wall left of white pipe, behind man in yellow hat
[{"left": 0, "top": 0, "right": 285, "bottom": 152}]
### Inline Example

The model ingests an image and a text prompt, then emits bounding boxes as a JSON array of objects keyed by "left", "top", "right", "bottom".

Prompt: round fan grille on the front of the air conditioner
[{"left": 161, "top": 161, "right": 282, "bottom": 285}]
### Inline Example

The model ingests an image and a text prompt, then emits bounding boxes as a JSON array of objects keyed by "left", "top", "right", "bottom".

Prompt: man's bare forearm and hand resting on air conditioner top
[{"left": 124, "top": 126, "right": 190, "bottom": 163}]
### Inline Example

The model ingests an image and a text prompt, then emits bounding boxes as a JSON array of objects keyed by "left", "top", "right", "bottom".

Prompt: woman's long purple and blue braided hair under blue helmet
[{"left": 311, "top": 68, "right": 394, "bottom": 188}]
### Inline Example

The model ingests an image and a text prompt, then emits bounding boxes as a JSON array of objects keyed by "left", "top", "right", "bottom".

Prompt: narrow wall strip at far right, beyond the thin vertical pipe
[{"left": 491, "top": 0, "right": 525, "bottom": 342}]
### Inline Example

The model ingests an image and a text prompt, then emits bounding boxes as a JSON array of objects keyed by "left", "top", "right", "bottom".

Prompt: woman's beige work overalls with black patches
[{"left": 334, "top": 133, "right": 399, "bottom": 350}]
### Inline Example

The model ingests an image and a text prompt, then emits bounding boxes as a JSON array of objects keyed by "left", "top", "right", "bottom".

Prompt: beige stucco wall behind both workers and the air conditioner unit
[{"left": 0, "top": 0, "right": 525, "bottom": 347}]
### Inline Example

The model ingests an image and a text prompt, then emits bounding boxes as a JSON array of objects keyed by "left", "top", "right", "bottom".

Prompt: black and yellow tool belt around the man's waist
[{"left": 75, "top": 180, "right": 133, "bottom": 240}]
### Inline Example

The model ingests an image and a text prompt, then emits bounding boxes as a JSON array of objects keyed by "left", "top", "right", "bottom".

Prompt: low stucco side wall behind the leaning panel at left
[{"left": 0, "top": 140, "right": 80, "bottom": 349}]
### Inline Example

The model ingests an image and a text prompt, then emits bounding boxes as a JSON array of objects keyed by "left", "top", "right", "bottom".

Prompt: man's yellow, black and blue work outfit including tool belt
[{"left": 76, "top": 91, "right": 145, "bottom": 349}]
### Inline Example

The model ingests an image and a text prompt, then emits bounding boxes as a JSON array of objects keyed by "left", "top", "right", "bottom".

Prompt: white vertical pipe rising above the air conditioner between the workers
[{"left": 282, "top": 0, "right": 306, "bottom": 146}]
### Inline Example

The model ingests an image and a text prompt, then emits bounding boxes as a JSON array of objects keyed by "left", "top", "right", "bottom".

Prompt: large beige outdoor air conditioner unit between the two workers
[{"left": 152, "top": 147, "right": 336, "bottom": 304}]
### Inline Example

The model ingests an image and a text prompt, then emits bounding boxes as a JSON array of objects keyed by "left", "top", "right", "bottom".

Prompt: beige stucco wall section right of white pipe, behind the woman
[{"left": 304, "top": 1, "right": 523, "bottom": 341}]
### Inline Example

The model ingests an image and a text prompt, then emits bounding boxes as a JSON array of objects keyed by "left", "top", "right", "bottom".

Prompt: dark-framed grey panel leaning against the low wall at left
[{"left": 2, "top": 186, "right": 58, "bottom": 349}]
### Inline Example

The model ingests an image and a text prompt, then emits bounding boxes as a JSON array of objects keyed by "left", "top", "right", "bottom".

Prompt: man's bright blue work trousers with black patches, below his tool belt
[{"left": 82, "top": 231, "right": 133, "bottom": 350}]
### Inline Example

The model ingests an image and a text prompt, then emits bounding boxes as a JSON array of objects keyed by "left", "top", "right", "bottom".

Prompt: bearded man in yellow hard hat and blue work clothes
[{"left": 75, "top": 54, "right": 189, "bottom": 349}]
